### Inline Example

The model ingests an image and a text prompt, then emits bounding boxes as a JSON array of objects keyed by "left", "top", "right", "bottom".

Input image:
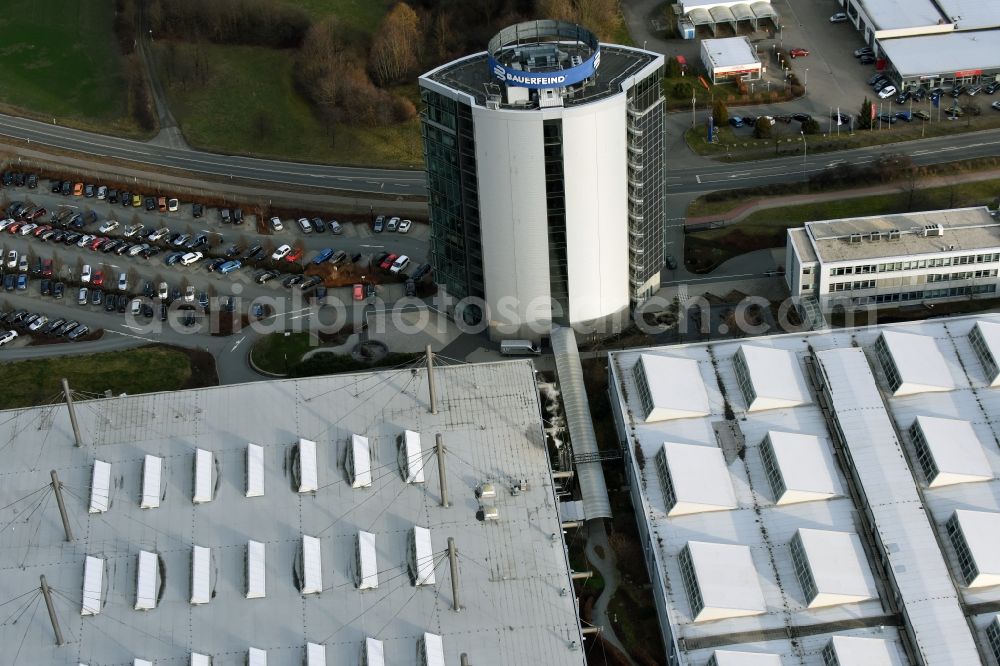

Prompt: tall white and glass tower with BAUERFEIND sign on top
[{"left": 420, "top": 21, "right": 665, "bottom": 339}]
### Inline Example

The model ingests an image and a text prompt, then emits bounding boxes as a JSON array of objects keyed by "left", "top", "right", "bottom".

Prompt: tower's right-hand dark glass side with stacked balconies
[{"left": 627, "top": 68, "right": 666, "bottom": 303}]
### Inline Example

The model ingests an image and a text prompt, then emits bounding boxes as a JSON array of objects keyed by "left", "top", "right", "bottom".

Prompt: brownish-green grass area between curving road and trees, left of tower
[{"left": 155, "top": 43, "right": 423, "bottom": 166}]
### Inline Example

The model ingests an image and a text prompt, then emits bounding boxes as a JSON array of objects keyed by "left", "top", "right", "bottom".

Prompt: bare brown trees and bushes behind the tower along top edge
[{"left": 115, "top": 0, "right": 621, "bottom": 132}]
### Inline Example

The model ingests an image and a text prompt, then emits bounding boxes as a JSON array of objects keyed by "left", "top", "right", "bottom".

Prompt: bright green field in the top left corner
[{"left": 0, "top": 0, "right": 137, "bottom": 135}]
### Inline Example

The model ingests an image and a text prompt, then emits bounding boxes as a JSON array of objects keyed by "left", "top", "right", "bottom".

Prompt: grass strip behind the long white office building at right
[{"left": 684, "top": 180, "right": 1000, "bottom": 273}]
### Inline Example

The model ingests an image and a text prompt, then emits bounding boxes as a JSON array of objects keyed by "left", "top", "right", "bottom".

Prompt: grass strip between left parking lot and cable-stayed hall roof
[{"left": 0, "top": 346, "right": 201, "bottom": 409}]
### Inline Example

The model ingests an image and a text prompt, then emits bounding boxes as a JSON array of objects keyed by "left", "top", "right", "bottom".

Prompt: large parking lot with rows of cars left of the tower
[{"left": 0, "top": 171, "right": 429, "bottom": 344}]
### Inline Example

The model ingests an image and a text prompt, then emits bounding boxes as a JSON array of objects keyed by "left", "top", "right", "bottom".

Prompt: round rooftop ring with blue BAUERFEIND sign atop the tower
[{"left": 488, "top": 21, "right": 601, "bottom": 89}]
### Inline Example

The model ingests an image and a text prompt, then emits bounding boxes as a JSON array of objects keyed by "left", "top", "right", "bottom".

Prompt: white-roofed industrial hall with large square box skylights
[{"left": 608, "top": 314, "right": 1000, "bottom": 666}]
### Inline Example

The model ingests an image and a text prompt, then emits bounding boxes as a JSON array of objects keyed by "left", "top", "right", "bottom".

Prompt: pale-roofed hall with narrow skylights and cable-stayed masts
[{"left": 0, "top": 361, "right": 585, "bottom": 666}]
